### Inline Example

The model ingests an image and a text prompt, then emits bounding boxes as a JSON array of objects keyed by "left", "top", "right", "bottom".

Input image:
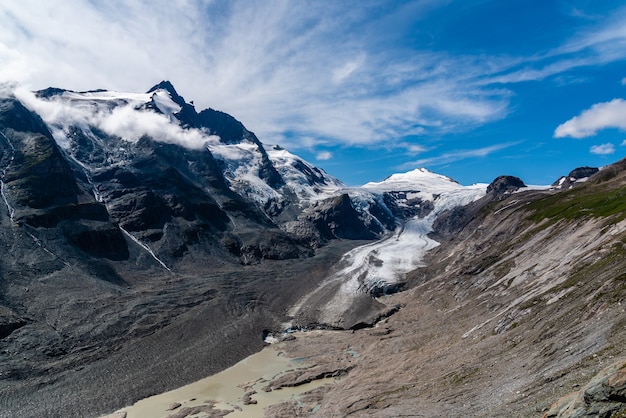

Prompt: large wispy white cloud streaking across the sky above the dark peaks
[{"left": 0, "top": 0, "right": 626, "bottom": 158}]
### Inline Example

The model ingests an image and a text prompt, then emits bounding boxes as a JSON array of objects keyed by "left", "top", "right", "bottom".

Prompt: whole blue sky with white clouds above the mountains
[{"left": 0, "top": 0, "right": 626, "bottom": 185}]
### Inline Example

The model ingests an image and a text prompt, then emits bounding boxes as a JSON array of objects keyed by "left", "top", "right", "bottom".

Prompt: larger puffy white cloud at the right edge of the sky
[{"left": 554, "top": 99, "right": 626, "bottom": 138}]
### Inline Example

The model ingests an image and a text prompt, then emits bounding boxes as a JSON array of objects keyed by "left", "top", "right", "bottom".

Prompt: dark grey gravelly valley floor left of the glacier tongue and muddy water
[{"left": 0, "top": 241, "right": 362, "bottom": 418}]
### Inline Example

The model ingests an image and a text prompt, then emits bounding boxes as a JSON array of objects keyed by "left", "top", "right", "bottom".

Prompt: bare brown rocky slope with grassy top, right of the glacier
[{"left": 260, "top": 161, "right": 626, "bottom": 417}]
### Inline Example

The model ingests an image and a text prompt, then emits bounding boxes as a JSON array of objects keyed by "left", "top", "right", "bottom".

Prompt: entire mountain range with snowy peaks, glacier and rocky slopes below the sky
[{"left": 0, "top": 81, "right": 626, "bottom": 417}]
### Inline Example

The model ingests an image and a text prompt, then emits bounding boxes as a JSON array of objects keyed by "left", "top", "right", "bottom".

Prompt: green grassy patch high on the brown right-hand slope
[{"left": 527, "top": 186, "right": 626, "bottom": 222}]
